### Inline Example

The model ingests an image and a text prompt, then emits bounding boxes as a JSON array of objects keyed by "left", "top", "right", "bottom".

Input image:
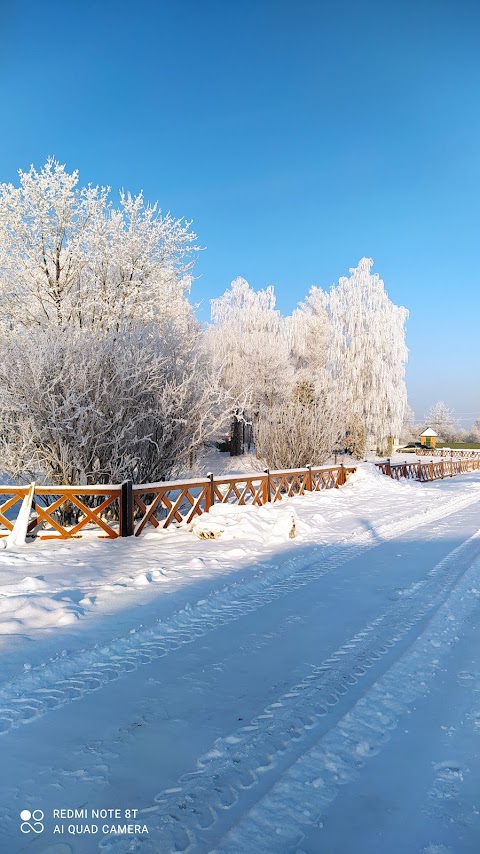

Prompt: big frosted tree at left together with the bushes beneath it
[{"left": 0, "top": 159, "right": 229, "bottom": 484}]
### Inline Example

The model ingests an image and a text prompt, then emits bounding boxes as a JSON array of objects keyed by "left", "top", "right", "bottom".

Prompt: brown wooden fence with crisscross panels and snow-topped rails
[{"left": 0, "top": 457, "right": 480, "bottom": 539}]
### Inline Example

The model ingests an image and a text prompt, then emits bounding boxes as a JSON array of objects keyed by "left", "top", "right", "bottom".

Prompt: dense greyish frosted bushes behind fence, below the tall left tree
[{"left": 0, "top": 329, "right": 225, "bottom": 484}]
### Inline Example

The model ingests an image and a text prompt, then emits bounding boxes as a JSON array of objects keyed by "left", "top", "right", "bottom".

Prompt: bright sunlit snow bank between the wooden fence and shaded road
[{"left": 0, "top": 464, "right": 480, "bottom": 666}]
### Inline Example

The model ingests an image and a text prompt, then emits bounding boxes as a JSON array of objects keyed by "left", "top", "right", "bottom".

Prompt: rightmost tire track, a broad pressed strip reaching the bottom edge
[{"left": 218, "top": 561, "right": 480, "bottom": 854}]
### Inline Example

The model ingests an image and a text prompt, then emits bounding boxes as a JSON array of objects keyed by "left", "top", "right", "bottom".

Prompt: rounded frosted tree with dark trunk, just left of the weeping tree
[{"left": 208, "top": 278, "right": 293, "bottom": 454}]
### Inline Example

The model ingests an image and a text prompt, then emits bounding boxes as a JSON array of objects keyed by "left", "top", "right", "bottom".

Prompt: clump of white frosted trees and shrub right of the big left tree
[{"left": 209, "top": 258, "right": 408, "bottom": 465}]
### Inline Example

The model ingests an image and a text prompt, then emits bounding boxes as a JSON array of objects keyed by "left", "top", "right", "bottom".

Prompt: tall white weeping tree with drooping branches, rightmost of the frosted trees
[{"left": 328, "top": 258, "right": 408, "bottom": 454}]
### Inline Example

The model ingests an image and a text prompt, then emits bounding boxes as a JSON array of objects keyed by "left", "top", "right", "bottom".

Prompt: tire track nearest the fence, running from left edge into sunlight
[{"left": 0, "top": 484, "right": 479, "bottom": 736}]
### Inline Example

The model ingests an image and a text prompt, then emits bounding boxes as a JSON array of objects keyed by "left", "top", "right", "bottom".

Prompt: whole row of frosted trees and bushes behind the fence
[{"left": 0, "top": 158, "right": 408, "bottom": 484}]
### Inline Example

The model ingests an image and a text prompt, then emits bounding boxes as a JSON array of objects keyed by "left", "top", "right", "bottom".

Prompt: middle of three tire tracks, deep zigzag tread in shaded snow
[{"left": 100, "top": 532, "right": 480, "bottom": 854}]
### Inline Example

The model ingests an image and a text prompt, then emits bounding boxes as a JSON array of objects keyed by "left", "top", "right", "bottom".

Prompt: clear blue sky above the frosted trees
[{"left": 0, "top": 0, "right": 480, "bottom": 426}]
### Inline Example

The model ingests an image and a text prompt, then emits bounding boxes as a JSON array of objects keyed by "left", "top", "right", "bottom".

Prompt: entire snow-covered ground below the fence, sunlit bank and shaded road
[{"left": 0, "top": 465, "right": 480, "bottom": 854}]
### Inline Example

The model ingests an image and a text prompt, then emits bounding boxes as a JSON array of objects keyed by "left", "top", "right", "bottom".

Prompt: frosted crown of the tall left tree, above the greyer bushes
[{"left": 0, "top": 158, "right": 198, "bottom": 331}]
